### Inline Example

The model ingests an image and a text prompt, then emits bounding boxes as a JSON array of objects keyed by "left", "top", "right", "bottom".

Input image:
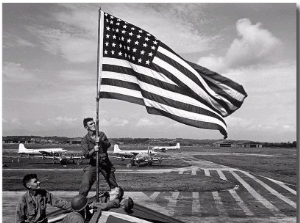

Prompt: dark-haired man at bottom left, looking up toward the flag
[{"left": 16, "top": 174, "right": 72, "bottom": 223}]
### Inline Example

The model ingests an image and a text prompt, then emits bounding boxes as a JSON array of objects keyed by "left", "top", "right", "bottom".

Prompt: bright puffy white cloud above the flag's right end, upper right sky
[{"left": 197, "top": 18, "right": 282, "bottom": 72}]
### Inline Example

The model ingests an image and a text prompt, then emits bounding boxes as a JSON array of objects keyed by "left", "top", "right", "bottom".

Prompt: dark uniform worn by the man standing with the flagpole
[{"left": 79, "top": 132, "right": 118, "bottom": 196}]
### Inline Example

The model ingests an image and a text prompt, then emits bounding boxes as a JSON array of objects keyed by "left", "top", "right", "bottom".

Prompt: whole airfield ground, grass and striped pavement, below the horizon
[{"left": 2, "top": 145, "right": 297, "bottom": 222}]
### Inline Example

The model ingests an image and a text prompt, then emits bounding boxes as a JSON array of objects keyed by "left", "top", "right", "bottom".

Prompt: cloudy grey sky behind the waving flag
[{"left": 2, "top": 3, "right": 297, "bottom": 142}]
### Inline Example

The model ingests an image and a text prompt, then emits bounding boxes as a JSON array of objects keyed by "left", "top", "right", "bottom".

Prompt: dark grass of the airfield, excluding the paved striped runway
[{"left": 2, "top": 145, "right": 297, "bottom": 191}]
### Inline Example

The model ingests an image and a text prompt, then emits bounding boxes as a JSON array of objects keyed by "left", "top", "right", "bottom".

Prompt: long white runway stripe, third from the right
[{"left": 230, "top": 171, "right": 286, "bottom": 217}]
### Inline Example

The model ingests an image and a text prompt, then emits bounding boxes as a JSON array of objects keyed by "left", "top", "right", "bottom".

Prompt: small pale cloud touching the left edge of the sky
[{"left": 2, "top": 62, "right": 34, "bottom": 82}]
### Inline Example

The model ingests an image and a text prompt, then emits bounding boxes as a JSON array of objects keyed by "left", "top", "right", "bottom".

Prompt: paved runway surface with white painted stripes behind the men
[{"left": 2, "top": 156, "right": 297, "bottom": 223}]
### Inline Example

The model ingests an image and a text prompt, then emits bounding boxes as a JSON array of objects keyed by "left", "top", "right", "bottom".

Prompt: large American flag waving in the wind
[{"left": 98, "top": 11, "right": 247, "bottom": 138}]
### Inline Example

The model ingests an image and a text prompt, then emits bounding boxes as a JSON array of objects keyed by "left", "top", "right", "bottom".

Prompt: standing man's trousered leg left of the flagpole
[{"left": 79, "top": 165, "right": 96, "bottom": 196}]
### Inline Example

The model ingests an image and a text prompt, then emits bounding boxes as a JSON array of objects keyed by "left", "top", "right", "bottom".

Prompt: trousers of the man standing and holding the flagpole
[{"left": 79, "top": 165, "right": 118, "bottom": 196}]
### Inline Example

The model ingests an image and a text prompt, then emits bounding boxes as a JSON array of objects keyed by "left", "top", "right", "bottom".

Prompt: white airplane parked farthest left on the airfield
[{"left": 18, "top": 143, "right": 67, "bottom": 157}]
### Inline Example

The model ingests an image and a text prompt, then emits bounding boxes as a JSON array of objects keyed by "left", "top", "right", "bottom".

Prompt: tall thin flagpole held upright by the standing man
[{"left": 96, "top": 7, "right": 101, "bottom": 202}]
